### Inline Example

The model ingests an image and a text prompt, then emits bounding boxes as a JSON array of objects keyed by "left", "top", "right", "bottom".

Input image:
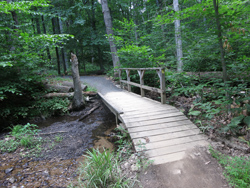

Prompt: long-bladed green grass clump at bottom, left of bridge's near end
[{"left": 75, "top": 149, "right": 134, "bottom": 188}]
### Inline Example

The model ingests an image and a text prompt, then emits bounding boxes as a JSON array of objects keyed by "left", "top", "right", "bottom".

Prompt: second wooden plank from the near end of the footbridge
[{"left": 145, "top": 140, "right": 208, "bottom": 157}]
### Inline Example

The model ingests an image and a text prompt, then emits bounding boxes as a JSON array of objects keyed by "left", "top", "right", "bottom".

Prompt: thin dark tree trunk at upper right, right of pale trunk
[{"left": 213, "top": 0, "right": 227, "bottom": 83}]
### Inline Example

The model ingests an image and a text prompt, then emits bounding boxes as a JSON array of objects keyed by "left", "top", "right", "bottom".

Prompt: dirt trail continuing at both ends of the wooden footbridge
[{"left": 81, "top": 76, "right": 230, "bottom": 188}]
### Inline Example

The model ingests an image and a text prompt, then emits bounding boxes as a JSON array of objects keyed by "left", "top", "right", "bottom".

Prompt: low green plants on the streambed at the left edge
[{"left": 0, "top": 123, "right": 41, "bottom": 153}]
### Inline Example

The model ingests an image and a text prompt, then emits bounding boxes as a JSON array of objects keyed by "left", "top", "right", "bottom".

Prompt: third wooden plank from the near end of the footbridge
[{"left": 135, "top": 134, "right": 207, "bottom": 151}]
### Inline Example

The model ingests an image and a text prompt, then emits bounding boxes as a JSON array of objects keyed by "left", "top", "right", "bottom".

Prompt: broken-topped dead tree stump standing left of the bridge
[{"left": 71, "top": 53, "right": 85, "bottom": 110}]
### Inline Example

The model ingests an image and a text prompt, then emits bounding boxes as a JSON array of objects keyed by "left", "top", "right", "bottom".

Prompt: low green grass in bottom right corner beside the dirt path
[{"left": 210, "top": 148, "right": 250, "bottom": 188}]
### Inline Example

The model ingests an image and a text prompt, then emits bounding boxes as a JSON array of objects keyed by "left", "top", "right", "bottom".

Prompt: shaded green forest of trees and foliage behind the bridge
[{"left": 0, "top": 0, "right": 250, "bottom": 136}]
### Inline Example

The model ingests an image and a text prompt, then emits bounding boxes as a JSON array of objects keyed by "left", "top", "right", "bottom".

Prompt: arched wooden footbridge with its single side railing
[{"left": 81, "top": 68, "right": 208, "bottom": 164}]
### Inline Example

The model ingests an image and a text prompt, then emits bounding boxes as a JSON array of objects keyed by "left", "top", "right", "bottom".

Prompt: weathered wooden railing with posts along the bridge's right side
[{"left": 118, "top": 67, "right": 166, "bottom": 104}]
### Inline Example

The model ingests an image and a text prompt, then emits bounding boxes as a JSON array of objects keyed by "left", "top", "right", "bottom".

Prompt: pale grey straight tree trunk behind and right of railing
[{"left": 173, "top": 0, "right": 183, "bottom": 72}]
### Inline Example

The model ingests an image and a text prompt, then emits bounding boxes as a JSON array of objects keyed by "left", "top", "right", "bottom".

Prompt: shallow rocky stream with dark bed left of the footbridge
[{"left": 0, "top": 99, "right": 116, "bottom": 188}]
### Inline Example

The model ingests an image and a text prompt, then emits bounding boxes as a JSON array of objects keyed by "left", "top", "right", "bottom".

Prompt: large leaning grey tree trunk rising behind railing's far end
[{"left": 101, "top": 0, "right": 120, "bottom": 68}]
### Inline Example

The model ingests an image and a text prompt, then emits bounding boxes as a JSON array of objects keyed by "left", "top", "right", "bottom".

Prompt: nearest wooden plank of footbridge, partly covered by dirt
[{"left": 148, "top": 151, "right": 186, "bottom": 165}]
